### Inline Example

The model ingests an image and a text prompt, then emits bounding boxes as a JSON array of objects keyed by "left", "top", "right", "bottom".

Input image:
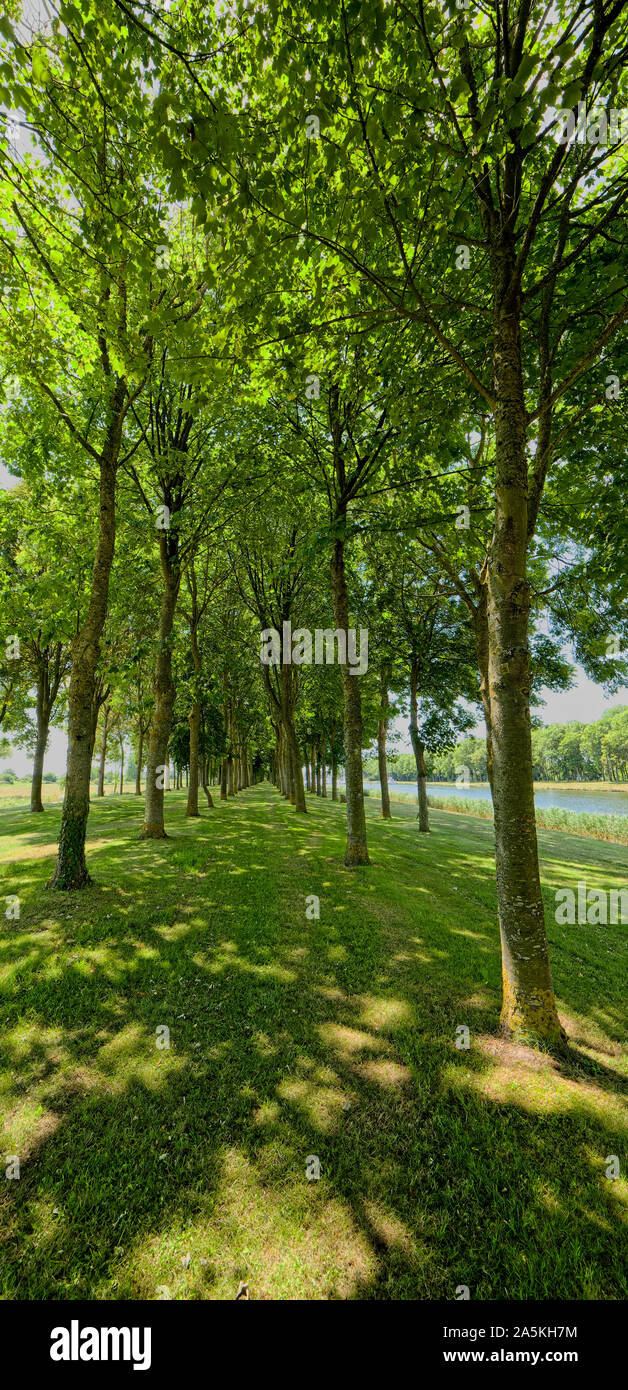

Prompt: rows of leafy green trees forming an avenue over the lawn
[{"left": 0, "top": 0, "right": 628, "bottom": 1043}]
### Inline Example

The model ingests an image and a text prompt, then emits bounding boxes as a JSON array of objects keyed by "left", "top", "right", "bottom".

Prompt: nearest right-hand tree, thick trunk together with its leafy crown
[{"left": 168, "top": 0, "right": 628, "bottom": 1041}]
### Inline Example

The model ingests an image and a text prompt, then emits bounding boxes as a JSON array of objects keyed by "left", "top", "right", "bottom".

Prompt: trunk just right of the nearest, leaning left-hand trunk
[{"left": 140, "top": 544, "right": 179, "bottom": 840}]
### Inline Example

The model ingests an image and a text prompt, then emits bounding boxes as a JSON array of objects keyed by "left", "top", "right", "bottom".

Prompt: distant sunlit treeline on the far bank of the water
[{"left": 364, "top": 705, "right": 628, "bottom": 783}]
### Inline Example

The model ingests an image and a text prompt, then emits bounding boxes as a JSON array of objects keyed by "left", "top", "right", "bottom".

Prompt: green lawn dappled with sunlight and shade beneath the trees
[{"left": 0, "top": 785, "right": 628, "bottom": 1300}]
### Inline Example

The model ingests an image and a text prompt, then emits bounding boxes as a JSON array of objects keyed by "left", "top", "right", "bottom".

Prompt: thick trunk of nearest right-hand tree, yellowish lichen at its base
[{"left": 488, "top": 282, "right": 563, "bottom": 1041}]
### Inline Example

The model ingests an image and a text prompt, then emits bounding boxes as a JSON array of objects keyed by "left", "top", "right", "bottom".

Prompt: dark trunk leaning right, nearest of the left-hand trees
[{"left": 49, "top": 422, "right": 126, "bottom": 888}]
